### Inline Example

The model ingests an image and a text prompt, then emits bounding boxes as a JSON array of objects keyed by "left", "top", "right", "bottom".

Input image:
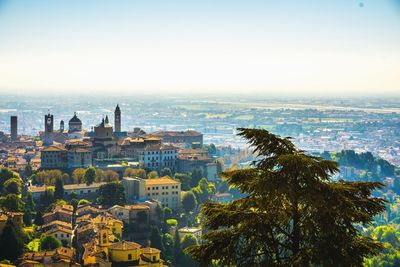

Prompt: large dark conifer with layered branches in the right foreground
[{"left": 186, "top": 129, "right": 385, "bottom": 266}]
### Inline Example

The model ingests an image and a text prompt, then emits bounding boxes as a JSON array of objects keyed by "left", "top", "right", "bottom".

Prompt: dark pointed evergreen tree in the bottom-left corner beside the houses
[{"left": 0, "top": 221, "right": 24, "bottom": 262}]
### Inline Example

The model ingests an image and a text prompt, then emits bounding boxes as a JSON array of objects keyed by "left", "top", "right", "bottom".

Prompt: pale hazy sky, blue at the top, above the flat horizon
[{"left": 0, "top": 0, "right": 400, "bottom": 96}]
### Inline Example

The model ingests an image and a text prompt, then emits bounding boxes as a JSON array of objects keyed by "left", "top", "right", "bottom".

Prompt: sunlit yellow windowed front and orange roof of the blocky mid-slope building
[{"left": 145, "top": 176, "right": 181, "bottom": 210}]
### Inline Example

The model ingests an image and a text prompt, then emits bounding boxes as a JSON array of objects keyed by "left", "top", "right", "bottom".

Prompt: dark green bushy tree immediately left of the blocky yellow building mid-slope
[{"left": 97, "top": 182, "right": 126, "bottom": 206}]
